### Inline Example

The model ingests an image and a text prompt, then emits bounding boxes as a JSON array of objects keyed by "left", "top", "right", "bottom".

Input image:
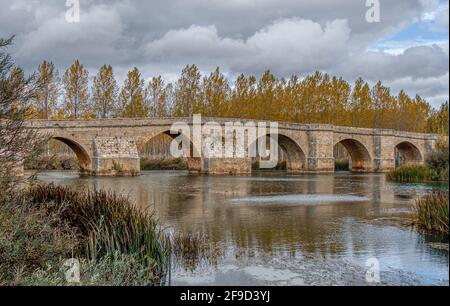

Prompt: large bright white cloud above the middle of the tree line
[{"left": 145, "top": 18, "right": 350, "bottom": 75}]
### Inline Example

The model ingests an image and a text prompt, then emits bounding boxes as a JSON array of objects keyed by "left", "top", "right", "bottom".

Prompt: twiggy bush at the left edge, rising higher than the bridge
[{"left": 0, "top": 37, "right": 47, "bottom": 204}]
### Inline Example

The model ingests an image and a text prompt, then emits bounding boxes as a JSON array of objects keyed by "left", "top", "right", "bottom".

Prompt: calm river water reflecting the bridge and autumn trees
[{"left": 40, "top": 172, "right": 449, "bottom": 285}]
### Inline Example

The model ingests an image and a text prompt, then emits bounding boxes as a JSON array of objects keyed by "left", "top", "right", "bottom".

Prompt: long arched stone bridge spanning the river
[{"left": 22, "top": 118, "right": 438, "bottom": 176}]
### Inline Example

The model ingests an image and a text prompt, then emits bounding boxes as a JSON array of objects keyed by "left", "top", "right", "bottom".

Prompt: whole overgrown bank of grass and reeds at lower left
[{"left": 0, "top": 185, "right": 213, "bottom": 286}]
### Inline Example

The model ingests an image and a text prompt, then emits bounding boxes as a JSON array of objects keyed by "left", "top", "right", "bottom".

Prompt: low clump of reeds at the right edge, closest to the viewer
[{"left": 414, "top": 191, "right": 449, "bottom": 235}]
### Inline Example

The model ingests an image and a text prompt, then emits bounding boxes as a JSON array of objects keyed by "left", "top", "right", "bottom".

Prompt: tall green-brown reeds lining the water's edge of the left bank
[{"left": 27, "top": 185, "right": 171, "bottom": 284}]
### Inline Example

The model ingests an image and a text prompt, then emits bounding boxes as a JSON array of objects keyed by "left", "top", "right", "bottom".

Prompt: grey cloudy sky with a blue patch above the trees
[{"left": 0, "top": 0, "right": 449, "bottom": 105}]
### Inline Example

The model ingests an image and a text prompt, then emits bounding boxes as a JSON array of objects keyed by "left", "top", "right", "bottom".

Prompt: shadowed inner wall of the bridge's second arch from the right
[{"left": 334, "top": 138, "right": 372, "bottom": 172}]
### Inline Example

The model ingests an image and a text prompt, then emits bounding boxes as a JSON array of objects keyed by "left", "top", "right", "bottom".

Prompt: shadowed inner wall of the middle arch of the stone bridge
[{"left": 250, "top": 134, "right": 306, "bottom": 173}]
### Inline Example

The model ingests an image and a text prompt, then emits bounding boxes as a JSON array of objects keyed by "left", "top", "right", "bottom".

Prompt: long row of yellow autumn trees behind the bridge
[{"left": 23, "top": 60, "right": 448, "bottom": 135}]
